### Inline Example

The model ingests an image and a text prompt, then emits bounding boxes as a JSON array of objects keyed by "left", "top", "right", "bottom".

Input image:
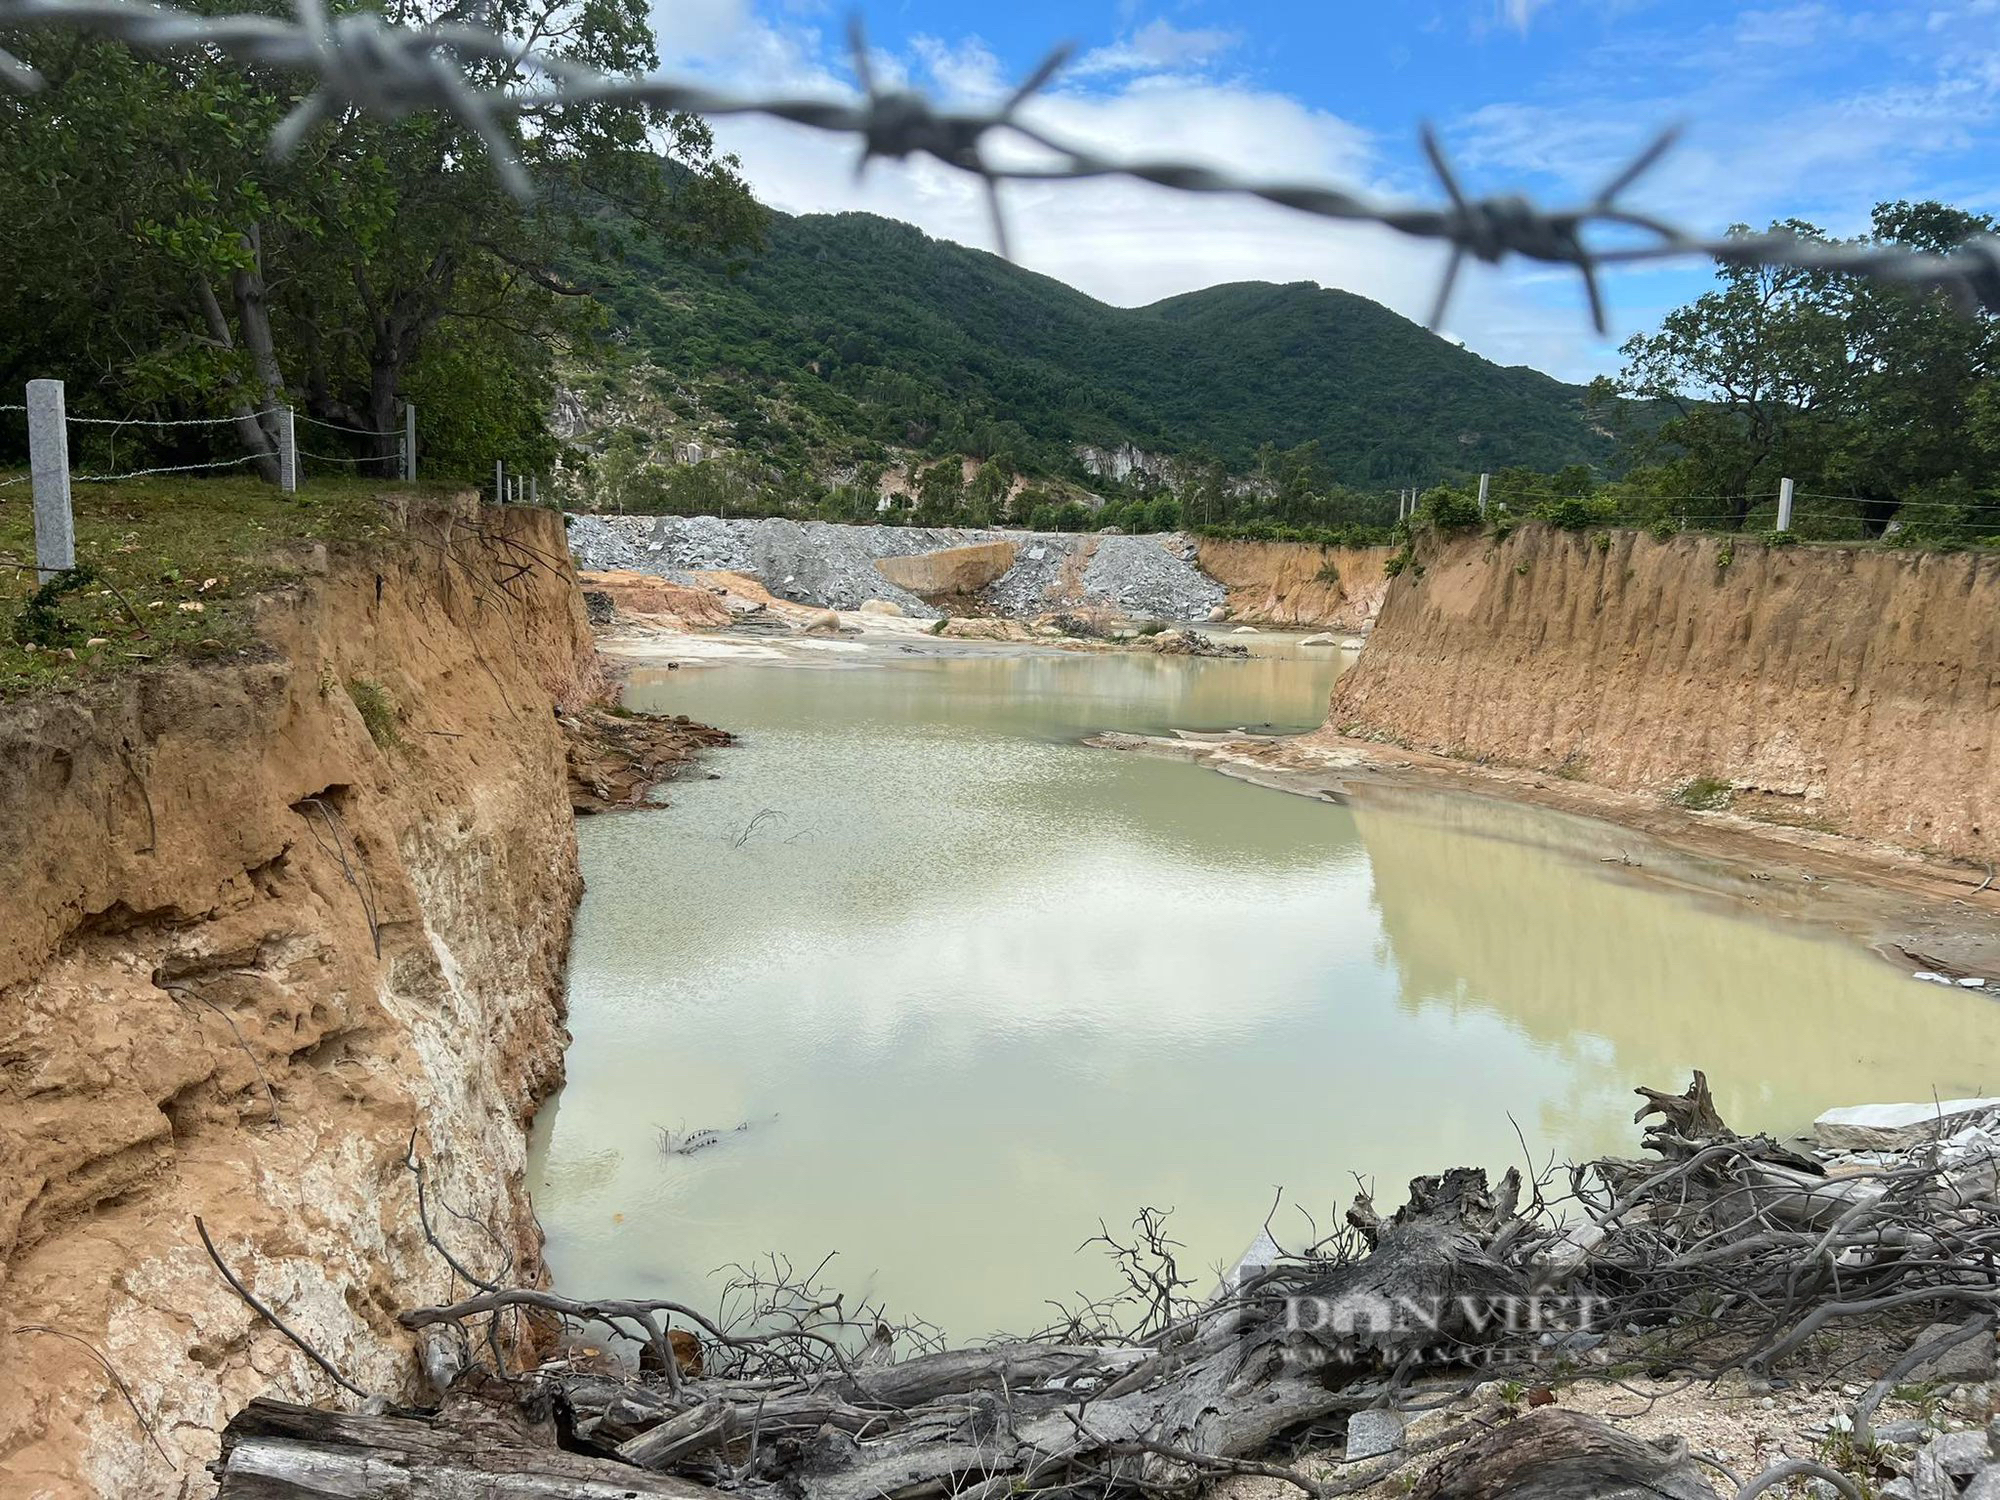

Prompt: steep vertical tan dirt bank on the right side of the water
[{"left": 1328, "top": 526, "right": 2000, "bottom": 862}]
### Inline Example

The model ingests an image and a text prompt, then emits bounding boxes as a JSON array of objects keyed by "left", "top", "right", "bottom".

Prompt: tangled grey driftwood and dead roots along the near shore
[{"left": 207, "top": 1074, "right": 2000, "bottom": 1500}]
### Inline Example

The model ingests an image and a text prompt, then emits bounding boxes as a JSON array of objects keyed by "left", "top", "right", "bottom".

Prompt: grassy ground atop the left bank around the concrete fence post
[{"left": 0, "top": 478, "right": 438, "bottom": 700}]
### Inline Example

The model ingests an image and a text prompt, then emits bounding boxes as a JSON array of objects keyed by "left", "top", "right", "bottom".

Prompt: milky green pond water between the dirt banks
[{"left": 532, "top": 650, "right": 2000, "bottom": 1338}]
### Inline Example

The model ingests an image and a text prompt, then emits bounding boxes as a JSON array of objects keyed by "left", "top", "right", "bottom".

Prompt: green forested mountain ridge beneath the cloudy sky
[{"left": 578, "top": 214, "right": 1614, "bottom": 488}]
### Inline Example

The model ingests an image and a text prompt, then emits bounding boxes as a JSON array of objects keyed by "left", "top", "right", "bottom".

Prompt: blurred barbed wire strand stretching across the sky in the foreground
[{"left": 0, "top": 0, "right": 2000, "bottom": 334}]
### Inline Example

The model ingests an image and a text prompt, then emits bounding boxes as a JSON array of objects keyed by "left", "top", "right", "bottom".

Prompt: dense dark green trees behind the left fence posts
[{"left": 0, "top": 0, "right": 762, "bottom": 476}]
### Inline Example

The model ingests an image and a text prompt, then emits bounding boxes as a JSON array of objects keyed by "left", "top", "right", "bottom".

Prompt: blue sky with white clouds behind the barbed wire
[{"left": 654, "top": 0, "right": 2000, "bottom": 378}]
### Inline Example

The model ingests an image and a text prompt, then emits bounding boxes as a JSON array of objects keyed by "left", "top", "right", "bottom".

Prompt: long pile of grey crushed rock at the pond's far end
[{"left": 570, "top": 516, "right": 1224, "bottom": 620}]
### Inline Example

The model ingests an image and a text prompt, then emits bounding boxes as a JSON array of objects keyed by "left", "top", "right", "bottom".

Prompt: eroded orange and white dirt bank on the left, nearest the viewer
[{"left": 0, "top": 506, "right": 596, "bottom": 1496}]
